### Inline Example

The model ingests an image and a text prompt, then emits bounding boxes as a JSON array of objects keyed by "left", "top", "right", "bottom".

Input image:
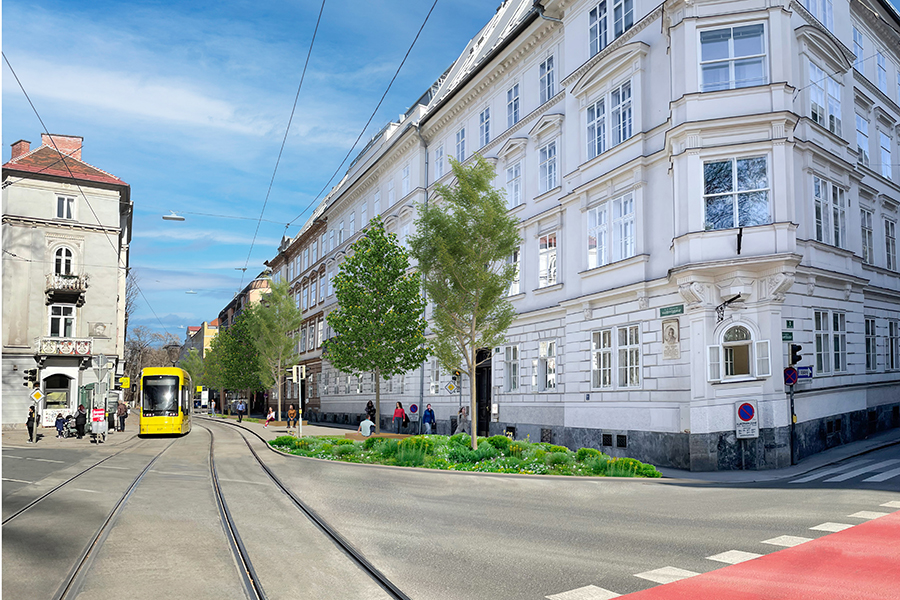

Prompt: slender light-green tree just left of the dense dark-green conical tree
[{"left": 252, "top": 281, "right": 303, "bottom": 421}]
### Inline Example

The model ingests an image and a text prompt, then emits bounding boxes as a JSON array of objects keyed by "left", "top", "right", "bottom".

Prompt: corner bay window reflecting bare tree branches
[{"left": 703, "top": 156, "right": 771, "bottom": 230}]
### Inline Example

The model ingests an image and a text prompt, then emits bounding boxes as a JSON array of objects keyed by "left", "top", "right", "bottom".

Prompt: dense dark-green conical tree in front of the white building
[{"left": 325, "top": 217, "right": 428, "bottom": 433}]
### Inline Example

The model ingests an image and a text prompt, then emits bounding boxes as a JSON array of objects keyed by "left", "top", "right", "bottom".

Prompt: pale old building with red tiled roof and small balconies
[{"left": 2, "top": 134, "right": 132, "bottom": 428}]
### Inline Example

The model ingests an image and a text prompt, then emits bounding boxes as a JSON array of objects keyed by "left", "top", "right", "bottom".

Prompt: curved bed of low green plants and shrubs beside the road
[{"left": 269, "top": 433, "right": 662, "bottom": 477}]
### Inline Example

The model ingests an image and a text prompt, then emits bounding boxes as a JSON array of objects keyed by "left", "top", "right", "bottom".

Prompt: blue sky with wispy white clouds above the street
[{"left": 2, "top": 0, "right": 500, "bottom": 339}]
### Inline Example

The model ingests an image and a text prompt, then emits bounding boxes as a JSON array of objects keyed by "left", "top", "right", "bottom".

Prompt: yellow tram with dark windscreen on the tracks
[{"left": 140, "top": 367, "right": 193, "bottom": 435}]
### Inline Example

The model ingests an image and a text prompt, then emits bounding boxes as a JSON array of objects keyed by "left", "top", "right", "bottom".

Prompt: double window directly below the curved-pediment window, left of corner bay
[{"left": 587, "top": 194, "right": 634, "bottom": 269}]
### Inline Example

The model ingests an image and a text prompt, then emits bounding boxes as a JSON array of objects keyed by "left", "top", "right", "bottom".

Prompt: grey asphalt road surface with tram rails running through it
[{"left": 3, "top": 421, "right": 900, "bottom": 600}]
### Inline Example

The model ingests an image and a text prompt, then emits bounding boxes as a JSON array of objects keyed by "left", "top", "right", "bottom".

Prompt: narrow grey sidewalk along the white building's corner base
[{"left": 657, "top": 429, "right": 900, "bottom": 483}]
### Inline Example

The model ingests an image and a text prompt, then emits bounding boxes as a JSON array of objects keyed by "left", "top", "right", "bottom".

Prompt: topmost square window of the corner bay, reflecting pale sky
[{"left": 700, "top": 24, "right": 766, "bottom": 92}]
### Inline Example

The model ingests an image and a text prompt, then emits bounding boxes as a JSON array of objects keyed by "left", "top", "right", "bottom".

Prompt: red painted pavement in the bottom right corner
[{"left": 622, "top": 508, "right": 900, "bottom": 600}]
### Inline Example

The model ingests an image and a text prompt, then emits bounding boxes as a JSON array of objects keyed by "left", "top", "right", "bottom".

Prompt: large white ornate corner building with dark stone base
[{"left": 276, "top": 0, "right": 900, "bottom": 470}]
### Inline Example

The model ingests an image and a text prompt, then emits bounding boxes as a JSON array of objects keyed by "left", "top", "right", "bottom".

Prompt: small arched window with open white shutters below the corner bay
[{"left": 708, "top": 325, "right": 772, "bottom": 381}]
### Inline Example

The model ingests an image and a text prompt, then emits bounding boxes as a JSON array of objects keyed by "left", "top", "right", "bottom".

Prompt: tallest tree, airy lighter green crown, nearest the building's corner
[{"left": 409, "top": 155, "right": 522, "bottom": 448}]
